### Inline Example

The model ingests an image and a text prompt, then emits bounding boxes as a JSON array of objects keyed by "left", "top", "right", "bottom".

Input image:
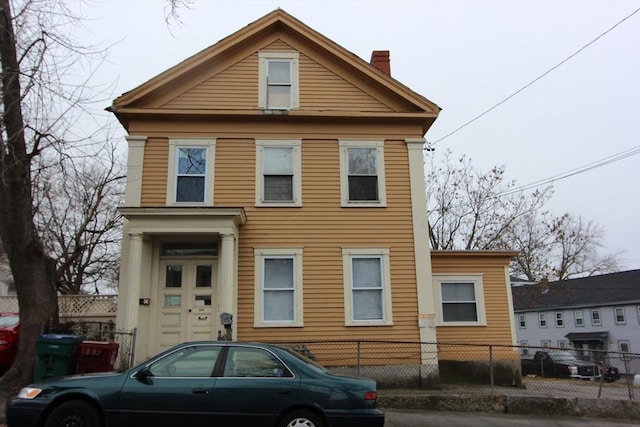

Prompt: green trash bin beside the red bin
[{"left": 34, "top": 334, "right": 84, "bottom": 381}]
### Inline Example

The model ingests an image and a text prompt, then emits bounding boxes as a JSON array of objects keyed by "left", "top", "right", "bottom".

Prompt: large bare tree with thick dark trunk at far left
[{"left": 0, "top": 0, "right": 112, "bottom": 392}]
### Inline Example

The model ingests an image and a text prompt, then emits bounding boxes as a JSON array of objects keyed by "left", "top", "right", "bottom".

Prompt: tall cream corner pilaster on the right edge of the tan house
[{"left": 405, "top": 138, "right": 437, "bottom": 348}]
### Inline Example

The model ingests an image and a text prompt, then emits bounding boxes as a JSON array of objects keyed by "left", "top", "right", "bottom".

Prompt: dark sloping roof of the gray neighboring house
[{"left": 511, "top": 270, "right": 640, "bottom": 311}]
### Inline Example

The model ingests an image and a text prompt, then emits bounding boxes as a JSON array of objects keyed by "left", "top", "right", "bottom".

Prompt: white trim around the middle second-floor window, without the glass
[{"left": 255, "top": 139, "right": 302, "bottom": 207}]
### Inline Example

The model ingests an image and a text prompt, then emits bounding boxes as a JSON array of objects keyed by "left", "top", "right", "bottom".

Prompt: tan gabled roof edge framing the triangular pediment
[{"left": 108, "top": 9, "right": 440, "bottom": 131}]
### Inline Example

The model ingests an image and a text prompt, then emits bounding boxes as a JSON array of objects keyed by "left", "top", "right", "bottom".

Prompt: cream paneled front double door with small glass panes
[{"left": 159, "top": 258, "right": 217, "bottom": 351}]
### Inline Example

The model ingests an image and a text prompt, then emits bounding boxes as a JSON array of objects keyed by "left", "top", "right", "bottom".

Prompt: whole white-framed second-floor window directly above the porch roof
[{"left": 166, "top": 138, "right": 216, "bottom": 206}]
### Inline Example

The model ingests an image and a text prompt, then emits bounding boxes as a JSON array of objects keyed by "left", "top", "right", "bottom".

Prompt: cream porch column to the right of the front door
[{"left": 218, "top": 233, "right": 238, "bottom": 337}]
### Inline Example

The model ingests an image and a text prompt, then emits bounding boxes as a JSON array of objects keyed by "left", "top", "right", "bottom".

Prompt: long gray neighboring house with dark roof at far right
[{"left": 511, "top": 270, "right": 640, "bottom": 356}]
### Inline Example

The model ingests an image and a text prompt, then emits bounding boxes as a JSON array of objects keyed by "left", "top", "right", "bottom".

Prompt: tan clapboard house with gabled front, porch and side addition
[{"left": 110, "top": 10, "right": 513, "bottom": 372}]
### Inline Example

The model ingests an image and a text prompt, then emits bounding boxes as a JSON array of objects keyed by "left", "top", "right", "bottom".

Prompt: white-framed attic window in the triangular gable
[{"left": 258, "top": 52, "right": 300, "bottom": 110}]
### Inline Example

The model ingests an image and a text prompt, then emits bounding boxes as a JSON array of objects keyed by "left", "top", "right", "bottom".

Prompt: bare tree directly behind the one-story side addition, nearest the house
[{"left": 428, "top": 151, "right": 551, "bottom": 250}]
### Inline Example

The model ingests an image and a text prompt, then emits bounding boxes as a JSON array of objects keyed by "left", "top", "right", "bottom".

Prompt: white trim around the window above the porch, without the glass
[{"left": 166, "top": 138, "right": 216, "bottom": 206}]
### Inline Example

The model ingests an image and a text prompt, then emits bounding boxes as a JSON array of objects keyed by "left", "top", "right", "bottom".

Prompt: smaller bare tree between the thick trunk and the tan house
[{"left": 34, "top": 144, "right": 124, "bottom": 294}]
